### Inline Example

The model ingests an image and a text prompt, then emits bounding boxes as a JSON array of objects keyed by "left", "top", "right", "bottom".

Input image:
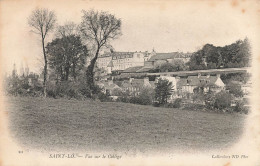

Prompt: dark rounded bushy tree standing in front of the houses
[{"left": 155, "top": 78, "right": 172, "bottom": 104}]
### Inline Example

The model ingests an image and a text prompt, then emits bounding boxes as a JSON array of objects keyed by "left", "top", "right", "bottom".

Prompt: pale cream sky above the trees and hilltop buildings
[{"left": 0, "top": 0, "right": 260, "bottom": 73}]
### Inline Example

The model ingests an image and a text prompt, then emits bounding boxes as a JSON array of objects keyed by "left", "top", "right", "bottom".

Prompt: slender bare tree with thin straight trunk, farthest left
[{"left": 28, "top": 9, "right": 56, "bottom": 97}]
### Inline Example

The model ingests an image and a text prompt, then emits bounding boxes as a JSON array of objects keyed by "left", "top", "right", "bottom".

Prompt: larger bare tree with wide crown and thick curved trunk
[{"left": 80, "top": 10, "right": 121, "bottom": 93}]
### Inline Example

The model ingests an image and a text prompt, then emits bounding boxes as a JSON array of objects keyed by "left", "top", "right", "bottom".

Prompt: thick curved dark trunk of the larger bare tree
[{"left": 86, "top": 46, "right": 100, "bottom": 95}]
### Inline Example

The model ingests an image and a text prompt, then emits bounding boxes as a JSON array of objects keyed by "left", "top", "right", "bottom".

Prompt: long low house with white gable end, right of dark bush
[{"left": 176, "top": 74, "right": 225, "bottom": 97}]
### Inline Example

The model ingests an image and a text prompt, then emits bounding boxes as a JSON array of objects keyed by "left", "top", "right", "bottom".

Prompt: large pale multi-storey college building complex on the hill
[{"left": 97, "top": 50, "right": 191, "bottom": 74}]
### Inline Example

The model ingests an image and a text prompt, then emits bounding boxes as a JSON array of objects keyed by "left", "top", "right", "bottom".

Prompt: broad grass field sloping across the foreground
[{"left": 8, "top": 97, "right": 246, "bottom": 153}]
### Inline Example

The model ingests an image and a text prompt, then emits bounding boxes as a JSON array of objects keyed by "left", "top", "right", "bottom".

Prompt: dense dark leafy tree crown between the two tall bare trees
[{"left": 46, "top": 35, "right": 88, "bottom": 81}]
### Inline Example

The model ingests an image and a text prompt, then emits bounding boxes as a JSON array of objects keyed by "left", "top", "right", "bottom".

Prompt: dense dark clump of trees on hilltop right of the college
[{"left": 188, "top": 38, "right": 251, "bottom": 70}]
